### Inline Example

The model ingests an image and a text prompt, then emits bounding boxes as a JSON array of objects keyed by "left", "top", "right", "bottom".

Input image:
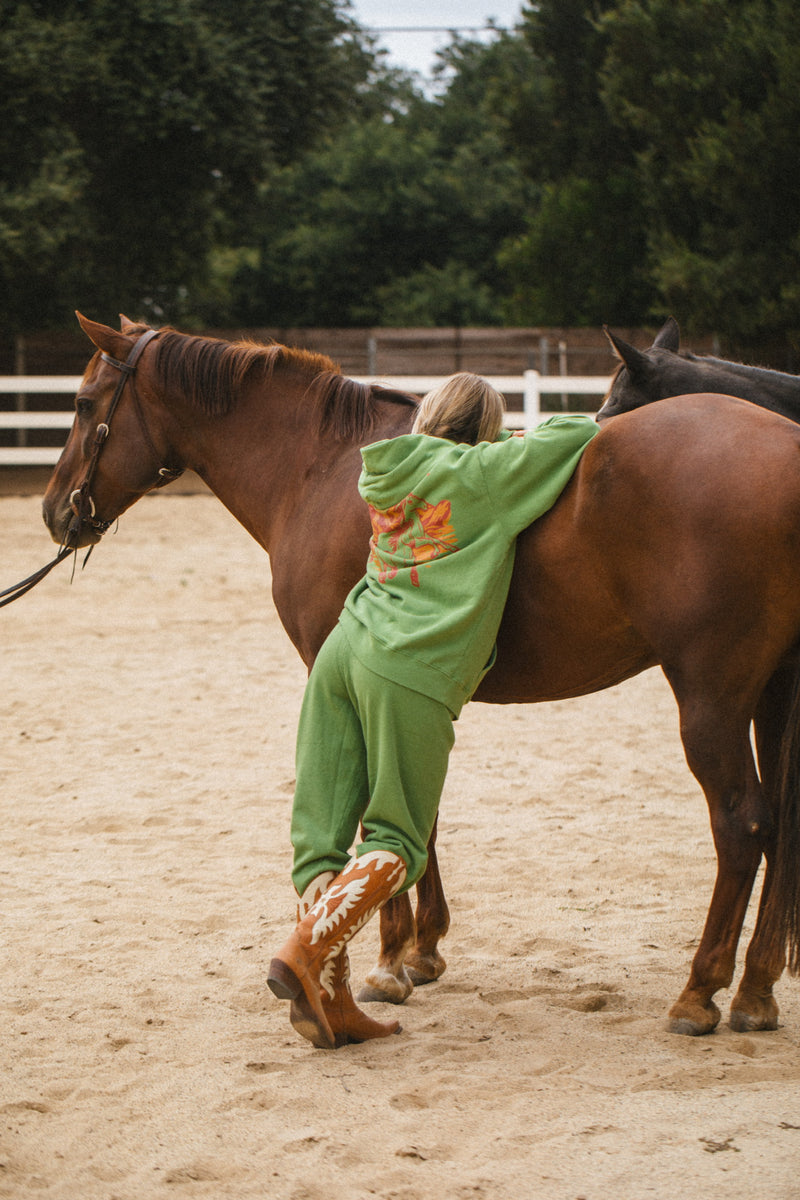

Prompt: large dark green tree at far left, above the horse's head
[{"left": 0, "top": 0, "right": 374, "bottom": 330}]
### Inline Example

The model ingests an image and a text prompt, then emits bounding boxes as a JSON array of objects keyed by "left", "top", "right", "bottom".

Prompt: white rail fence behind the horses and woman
[{"left": 0, "top": 371, "right": 610, "bottom": 467}]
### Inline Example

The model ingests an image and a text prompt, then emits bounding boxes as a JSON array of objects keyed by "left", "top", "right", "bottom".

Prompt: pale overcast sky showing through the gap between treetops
[{"left": 351, "top": 0, "right": 522, "bottom": 76}]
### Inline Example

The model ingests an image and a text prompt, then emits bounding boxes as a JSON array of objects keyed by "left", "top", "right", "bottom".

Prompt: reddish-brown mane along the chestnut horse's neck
[{"left": 143, "top": 326, "right": 416, "bottom": 440}]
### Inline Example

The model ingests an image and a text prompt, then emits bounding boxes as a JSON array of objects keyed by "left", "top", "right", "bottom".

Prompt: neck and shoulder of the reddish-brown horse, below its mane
[{"left": 161, "top": 372, "right": 414, "bottom": 666}]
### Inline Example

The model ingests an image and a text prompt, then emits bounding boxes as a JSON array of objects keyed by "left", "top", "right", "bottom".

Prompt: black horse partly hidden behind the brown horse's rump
[{"left": 597, "top": 317, "right": 800, "bottom": 424}]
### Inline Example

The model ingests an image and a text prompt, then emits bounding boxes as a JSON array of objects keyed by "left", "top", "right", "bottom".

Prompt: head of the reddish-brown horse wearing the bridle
[{"left": 42, "top": 313, "right": 180, "bottom": 547}]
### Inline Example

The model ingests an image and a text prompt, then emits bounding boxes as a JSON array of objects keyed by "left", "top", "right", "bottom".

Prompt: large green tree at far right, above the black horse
[{"left": 604, "top": 0, "right": 800, "bottom": 352}]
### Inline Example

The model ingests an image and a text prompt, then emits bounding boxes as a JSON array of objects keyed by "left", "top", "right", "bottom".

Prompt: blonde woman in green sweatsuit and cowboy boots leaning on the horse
[{"left": 267, "top": 373, "right": 599, "bottom": 1049}]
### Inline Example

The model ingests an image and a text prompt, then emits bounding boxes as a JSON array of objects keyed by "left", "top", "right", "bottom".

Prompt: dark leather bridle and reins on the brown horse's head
[{"left": 0, "top": 329, "right": 184, "bottom": 608}]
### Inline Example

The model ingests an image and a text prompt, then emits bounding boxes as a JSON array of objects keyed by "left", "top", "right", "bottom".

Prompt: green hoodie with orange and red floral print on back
[{"left": 339, "top": 416, "right": 599, "bottom": 716}]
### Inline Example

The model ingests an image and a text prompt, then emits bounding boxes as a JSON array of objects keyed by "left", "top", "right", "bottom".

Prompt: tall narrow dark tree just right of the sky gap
[{"left": 495, "top": 0, "right": 654, "bottom": 325}]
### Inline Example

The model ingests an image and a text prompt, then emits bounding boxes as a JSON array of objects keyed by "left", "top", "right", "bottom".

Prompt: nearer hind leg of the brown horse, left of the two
[{"left": 669, "top": 678, "right": 770, "bottom": 1034}]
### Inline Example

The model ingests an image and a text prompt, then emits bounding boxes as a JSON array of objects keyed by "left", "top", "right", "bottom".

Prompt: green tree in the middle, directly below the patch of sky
[{"left": 226, "top": 35, "right": 537, "bottom": 325}]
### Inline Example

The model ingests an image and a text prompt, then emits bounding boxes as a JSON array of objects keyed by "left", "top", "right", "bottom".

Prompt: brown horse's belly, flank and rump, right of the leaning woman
[{"left": 479, "top": 395, "right": 800, "bottom": 701}]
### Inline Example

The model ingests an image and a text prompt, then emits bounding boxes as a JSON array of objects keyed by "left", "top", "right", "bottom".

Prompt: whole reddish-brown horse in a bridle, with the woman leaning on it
[{"left": 44, "top": 319, "right": 800, "bottom": 1033}]
